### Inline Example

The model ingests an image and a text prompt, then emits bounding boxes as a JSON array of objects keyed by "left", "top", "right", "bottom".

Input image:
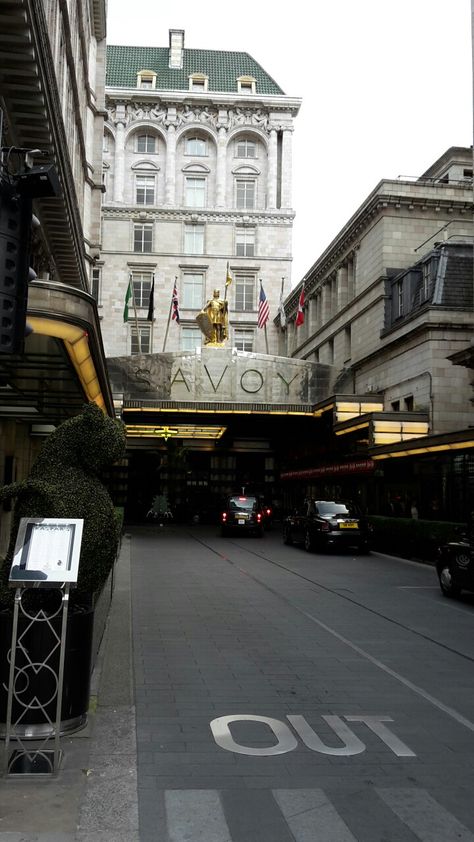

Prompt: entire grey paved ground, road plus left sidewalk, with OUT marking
[{"left": 0, "top": 528, "right": 474, "bottom": 842}]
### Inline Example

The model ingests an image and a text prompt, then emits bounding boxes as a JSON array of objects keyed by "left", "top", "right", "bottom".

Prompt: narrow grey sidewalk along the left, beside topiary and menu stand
[{"left": 0, "top": 537, "right": 139, "bottom": 842}]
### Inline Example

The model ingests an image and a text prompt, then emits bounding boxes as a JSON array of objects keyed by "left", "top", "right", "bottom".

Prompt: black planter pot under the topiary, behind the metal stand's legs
[{"left": 0, "top": 606, "right": 94, "bottom": 739}]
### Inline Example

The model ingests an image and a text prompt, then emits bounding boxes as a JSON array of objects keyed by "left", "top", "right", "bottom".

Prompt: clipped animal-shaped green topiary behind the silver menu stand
[{"left": 0, "top": 403, "right": 126, "bottom": 605}]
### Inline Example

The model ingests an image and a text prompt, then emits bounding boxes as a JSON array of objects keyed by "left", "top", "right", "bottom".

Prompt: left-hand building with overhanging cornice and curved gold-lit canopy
[{"left": 0, "top": 0, "right": 110, "bottom": 551}]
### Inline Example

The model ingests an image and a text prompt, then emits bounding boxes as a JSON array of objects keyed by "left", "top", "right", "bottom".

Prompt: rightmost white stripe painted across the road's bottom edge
[{"left": 376, "top": 787, "right": 474, "bottom": 842}]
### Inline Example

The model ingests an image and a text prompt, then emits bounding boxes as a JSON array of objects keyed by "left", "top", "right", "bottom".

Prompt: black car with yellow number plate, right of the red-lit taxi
[{"left": 283, "top": 500, "right": 370, "bottom": 553}]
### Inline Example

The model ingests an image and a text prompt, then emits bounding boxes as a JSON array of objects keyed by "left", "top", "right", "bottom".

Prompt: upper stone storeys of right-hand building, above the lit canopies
[{"left": 281, "top": 147, "right": 473, "bottom": 433}]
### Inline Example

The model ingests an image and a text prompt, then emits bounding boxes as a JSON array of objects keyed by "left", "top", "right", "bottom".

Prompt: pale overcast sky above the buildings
[{"left": 107, "top": 0, "right": 473, "bottom": 286}]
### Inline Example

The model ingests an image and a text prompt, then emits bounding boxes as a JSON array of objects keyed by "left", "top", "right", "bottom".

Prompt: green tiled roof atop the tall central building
[{"left": 106, "top": 46, "right": 284, "bottom": 94}]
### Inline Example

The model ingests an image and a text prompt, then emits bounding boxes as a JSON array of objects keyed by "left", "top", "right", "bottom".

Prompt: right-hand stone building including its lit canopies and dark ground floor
[{"left": 275, "top": 147, "right": 474, "bottom": 520}]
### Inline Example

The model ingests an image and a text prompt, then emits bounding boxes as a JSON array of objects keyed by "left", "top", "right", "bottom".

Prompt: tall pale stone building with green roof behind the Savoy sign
[{"left": 98, "top": 30, "right": 300, "bottom": 357}]
